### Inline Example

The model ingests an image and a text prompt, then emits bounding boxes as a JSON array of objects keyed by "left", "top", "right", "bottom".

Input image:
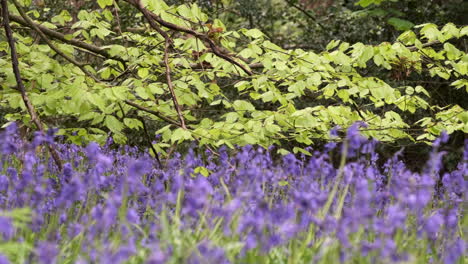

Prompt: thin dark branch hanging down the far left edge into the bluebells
[{"left": 1, "top": 0, "right": 63, "bottom": 170}]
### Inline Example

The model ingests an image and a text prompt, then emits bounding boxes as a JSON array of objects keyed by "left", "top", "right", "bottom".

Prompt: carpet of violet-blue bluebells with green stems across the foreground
[{"left": 0, "top": 124, "right": 468, "bottom": 264}]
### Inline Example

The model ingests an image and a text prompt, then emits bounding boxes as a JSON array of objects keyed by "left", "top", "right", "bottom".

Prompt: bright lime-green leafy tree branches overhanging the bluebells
[{"left": 0, "top": 0, "right": 468, "bottom": 156}]
